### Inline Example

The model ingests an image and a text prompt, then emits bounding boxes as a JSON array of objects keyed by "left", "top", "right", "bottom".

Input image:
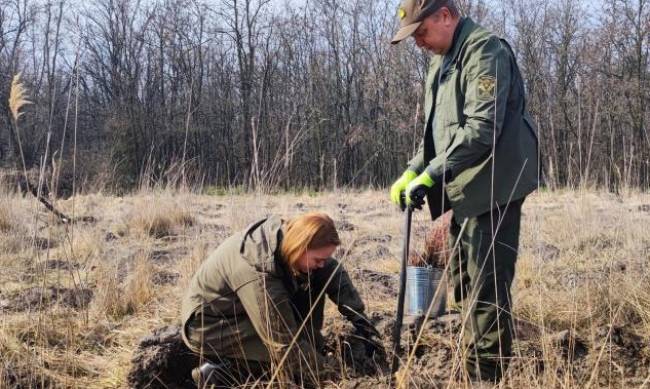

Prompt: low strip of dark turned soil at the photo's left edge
[{"left": 0, "top": 287, "right": 93, "bottom": 312}]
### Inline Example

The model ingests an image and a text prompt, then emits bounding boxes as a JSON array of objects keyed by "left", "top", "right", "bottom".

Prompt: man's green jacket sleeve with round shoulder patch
[{"left": 426, "top": 37, "right": 512, "bottom": 183}]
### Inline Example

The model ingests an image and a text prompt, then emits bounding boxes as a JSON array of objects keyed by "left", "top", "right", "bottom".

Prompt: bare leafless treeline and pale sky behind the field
[{"left": 0, "top": 0, "right": 650, "bottom": 191}]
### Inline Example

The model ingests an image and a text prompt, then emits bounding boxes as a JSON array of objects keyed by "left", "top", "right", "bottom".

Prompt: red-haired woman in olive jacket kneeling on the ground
[{"left": 182, "top": 213, "right": 377, "bottom": 386}]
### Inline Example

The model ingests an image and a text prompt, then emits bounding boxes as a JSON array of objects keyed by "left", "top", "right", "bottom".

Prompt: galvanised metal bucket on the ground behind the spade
[{"left": 406, "top": 266, "right": 447, "bottom": 318}]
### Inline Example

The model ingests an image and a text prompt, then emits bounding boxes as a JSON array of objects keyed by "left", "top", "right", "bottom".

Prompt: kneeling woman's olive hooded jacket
[{"left": 181, "top": 216, "right": 364, "bottom": 364}]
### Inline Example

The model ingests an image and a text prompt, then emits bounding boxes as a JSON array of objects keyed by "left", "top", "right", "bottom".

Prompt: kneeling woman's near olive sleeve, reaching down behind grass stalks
[{"left": 236, "top": 271, "right": 319, "bottom": 372}]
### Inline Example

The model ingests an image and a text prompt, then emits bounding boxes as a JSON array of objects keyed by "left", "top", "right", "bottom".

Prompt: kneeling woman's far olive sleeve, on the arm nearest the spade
[{"left": 323, "top": 258, "right": 365, "bottom": 323}]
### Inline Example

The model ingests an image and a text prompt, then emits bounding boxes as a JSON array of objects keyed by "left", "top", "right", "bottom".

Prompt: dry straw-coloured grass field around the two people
[{"left": 0, "top": 186, "right": 650, "bottom": 388}]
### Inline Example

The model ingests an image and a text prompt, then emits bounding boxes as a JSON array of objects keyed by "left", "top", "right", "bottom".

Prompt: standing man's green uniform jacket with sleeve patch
[{"left": 409, "top": 18, "right": 540, "bottom": 220}]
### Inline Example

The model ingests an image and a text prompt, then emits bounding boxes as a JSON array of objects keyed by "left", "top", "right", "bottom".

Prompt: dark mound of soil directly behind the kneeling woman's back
[{"left": 128, "top": 326, "right": 199, "bottom": 389}]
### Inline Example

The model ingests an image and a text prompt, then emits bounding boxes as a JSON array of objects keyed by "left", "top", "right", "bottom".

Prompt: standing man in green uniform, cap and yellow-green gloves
[{"left": 391, "top": 0, "right": 540, "bottom": 382}]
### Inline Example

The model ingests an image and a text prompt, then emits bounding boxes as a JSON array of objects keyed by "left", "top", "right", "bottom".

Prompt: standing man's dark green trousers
[{"left": 449, "top": 199, "right": 524, "bottom": 381}]
